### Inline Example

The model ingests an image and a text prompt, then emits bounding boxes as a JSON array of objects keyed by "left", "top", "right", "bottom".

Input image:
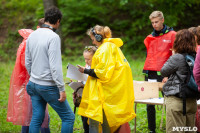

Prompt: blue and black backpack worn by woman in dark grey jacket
[{"left": 176, "top": 54, "right": 199, "bottom": 115}]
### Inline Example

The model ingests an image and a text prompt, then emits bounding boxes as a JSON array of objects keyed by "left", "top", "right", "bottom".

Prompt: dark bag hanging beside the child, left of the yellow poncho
[{"left": 73, "top": 86, "right": 83, "bottom": 114}]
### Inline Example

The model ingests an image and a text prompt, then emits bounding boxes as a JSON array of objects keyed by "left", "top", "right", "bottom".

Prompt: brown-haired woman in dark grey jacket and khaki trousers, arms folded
[{"left": 161, "top": 29, "right": 197, "bottom": 133}]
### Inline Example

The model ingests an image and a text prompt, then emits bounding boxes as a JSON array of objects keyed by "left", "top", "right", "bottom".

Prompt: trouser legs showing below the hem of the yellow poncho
[{"left": 89, "top": 111, "right": 111, "bottom": 133}]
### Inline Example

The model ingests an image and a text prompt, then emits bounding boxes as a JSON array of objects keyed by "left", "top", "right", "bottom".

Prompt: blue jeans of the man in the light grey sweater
[{"left": 26, "top": 81, "right": 75, "bottom": 133}]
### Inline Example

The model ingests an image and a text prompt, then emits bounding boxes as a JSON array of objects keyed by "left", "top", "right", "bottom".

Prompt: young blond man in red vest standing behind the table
[{"left": 143, "top": 11, "right": 176, "bottom": 133}]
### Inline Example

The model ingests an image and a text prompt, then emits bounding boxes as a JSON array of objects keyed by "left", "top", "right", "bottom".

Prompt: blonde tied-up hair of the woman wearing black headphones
[{"left": 87, "top": 25, "right": 112, "bottom": 39}]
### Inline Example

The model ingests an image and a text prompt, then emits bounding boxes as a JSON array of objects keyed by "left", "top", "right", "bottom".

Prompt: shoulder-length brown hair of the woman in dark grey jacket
[{"left": 173, "top": 29, "right": 196, "bottom": 54}]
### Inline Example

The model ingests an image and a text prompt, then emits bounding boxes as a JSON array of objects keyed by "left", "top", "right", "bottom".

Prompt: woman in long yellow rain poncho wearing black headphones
[{"left": 78, "top": 25, "right": 136, "bottom": 133}]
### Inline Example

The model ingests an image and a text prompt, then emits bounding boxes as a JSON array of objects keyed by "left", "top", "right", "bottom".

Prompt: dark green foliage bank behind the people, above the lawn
[{"left": 0, "top": 0, "right": 200, "bottom": 57}]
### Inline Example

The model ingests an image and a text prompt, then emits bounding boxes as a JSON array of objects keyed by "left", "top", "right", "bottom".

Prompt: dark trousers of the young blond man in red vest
[{"left": 145, "top": 71, "right": 163, "bottom": 133}]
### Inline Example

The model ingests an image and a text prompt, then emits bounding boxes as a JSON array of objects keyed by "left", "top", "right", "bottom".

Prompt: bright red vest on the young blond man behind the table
[{"left": 144, "top": 31, "right": 176, "bottom": 71}]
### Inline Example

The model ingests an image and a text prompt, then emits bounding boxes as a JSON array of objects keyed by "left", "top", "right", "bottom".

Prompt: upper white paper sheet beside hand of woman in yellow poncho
[{"left": 66, "top": 64, "right": 88, "bottom": 81}]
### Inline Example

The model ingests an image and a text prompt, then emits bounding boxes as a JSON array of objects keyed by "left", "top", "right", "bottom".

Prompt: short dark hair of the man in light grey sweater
[{"left": 44, "top": 6, "right": 62, "bottom": 24}]
